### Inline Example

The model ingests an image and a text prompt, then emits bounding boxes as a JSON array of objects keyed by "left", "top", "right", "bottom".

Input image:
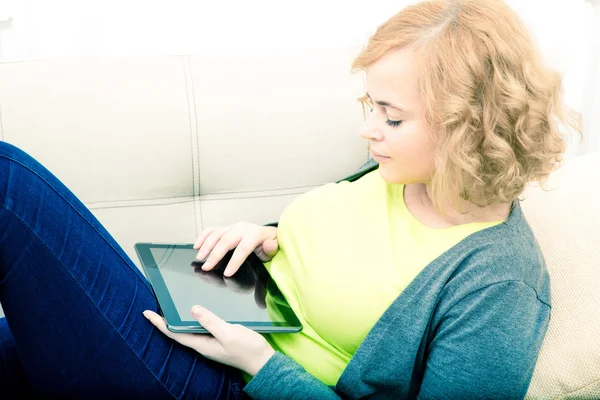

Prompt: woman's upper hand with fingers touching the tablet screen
[{"left": 194, "top": 221, "right": 279, "bottom": 276}]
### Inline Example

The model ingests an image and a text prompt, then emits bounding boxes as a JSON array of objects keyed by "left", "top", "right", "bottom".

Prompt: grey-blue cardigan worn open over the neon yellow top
[{"left": 244, "top": 162, "right": 550, "bottom": 400}]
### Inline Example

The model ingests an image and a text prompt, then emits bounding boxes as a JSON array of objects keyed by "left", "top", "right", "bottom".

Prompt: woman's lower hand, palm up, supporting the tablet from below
[{"left": 144, "top": 306, "right": 275, "bottom": 376}]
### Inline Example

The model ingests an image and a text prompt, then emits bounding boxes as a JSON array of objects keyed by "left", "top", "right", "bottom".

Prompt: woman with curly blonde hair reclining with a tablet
[{"left": 0, "top": 0, "right": 571, "bottom": 399}]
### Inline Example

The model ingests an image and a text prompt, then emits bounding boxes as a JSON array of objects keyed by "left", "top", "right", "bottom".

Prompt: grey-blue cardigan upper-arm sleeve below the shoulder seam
[{"left": 418, "top": 280, "right": 550, "bottom": 400}]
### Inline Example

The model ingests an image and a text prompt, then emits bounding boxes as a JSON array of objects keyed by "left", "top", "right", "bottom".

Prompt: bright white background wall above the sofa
[{"left": 0, "top": 0, "right": 600, "bottom": 152}]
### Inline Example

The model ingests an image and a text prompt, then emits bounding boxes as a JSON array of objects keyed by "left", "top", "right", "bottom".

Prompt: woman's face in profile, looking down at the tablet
[{"left": 361, "top": 48, "right": 435, "bottom": 184}]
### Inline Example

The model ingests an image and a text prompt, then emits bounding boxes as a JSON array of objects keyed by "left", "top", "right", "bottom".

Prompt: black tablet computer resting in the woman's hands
[{"left": 135, "top": 243, "right": 302, "bottom": 333}]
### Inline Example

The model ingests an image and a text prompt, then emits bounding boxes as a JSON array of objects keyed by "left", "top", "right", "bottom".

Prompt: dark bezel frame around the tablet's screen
[{"left": 134, "top": 242, "right": 302, "bottom": 333}]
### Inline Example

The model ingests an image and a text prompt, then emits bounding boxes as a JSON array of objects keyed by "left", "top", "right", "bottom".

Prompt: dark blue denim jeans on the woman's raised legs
[{"left": 0, "top": 141, "right": 247, "bottom": 399}]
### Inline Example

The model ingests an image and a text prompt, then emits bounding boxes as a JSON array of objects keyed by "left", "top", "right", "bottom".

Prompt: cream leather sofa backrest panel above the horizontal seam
[{"left": 0, "top": 50, "right": 368, "bottom": 229}]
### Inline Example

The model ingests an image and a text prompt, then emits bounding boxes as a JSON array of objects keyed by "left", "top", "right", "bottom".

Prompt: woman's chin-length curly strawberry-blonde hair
[{"left": 352, "top": 0, "right": 581, "bottom": 208}]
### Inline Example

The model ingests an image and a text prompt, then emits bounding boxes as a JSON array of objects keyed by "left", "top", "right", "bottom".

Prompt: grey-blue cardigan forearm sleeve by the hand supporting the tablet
[{"left": 244, "top": 352, "right": 341, "bottom": 400}]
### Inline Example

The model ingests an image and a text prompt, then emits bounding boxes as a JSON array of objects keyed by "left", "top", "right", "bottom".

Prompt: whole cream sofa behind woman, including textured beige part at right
[{"left": 0, "top": 54, "right": 600, "bottom": 398}]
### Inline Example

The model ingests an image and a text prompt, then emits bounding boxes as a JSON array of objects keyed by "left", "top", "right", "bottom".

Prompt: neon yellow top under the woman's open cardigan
[{"left": 246, "top": 170, "right": 501, "bottom": 386}]
